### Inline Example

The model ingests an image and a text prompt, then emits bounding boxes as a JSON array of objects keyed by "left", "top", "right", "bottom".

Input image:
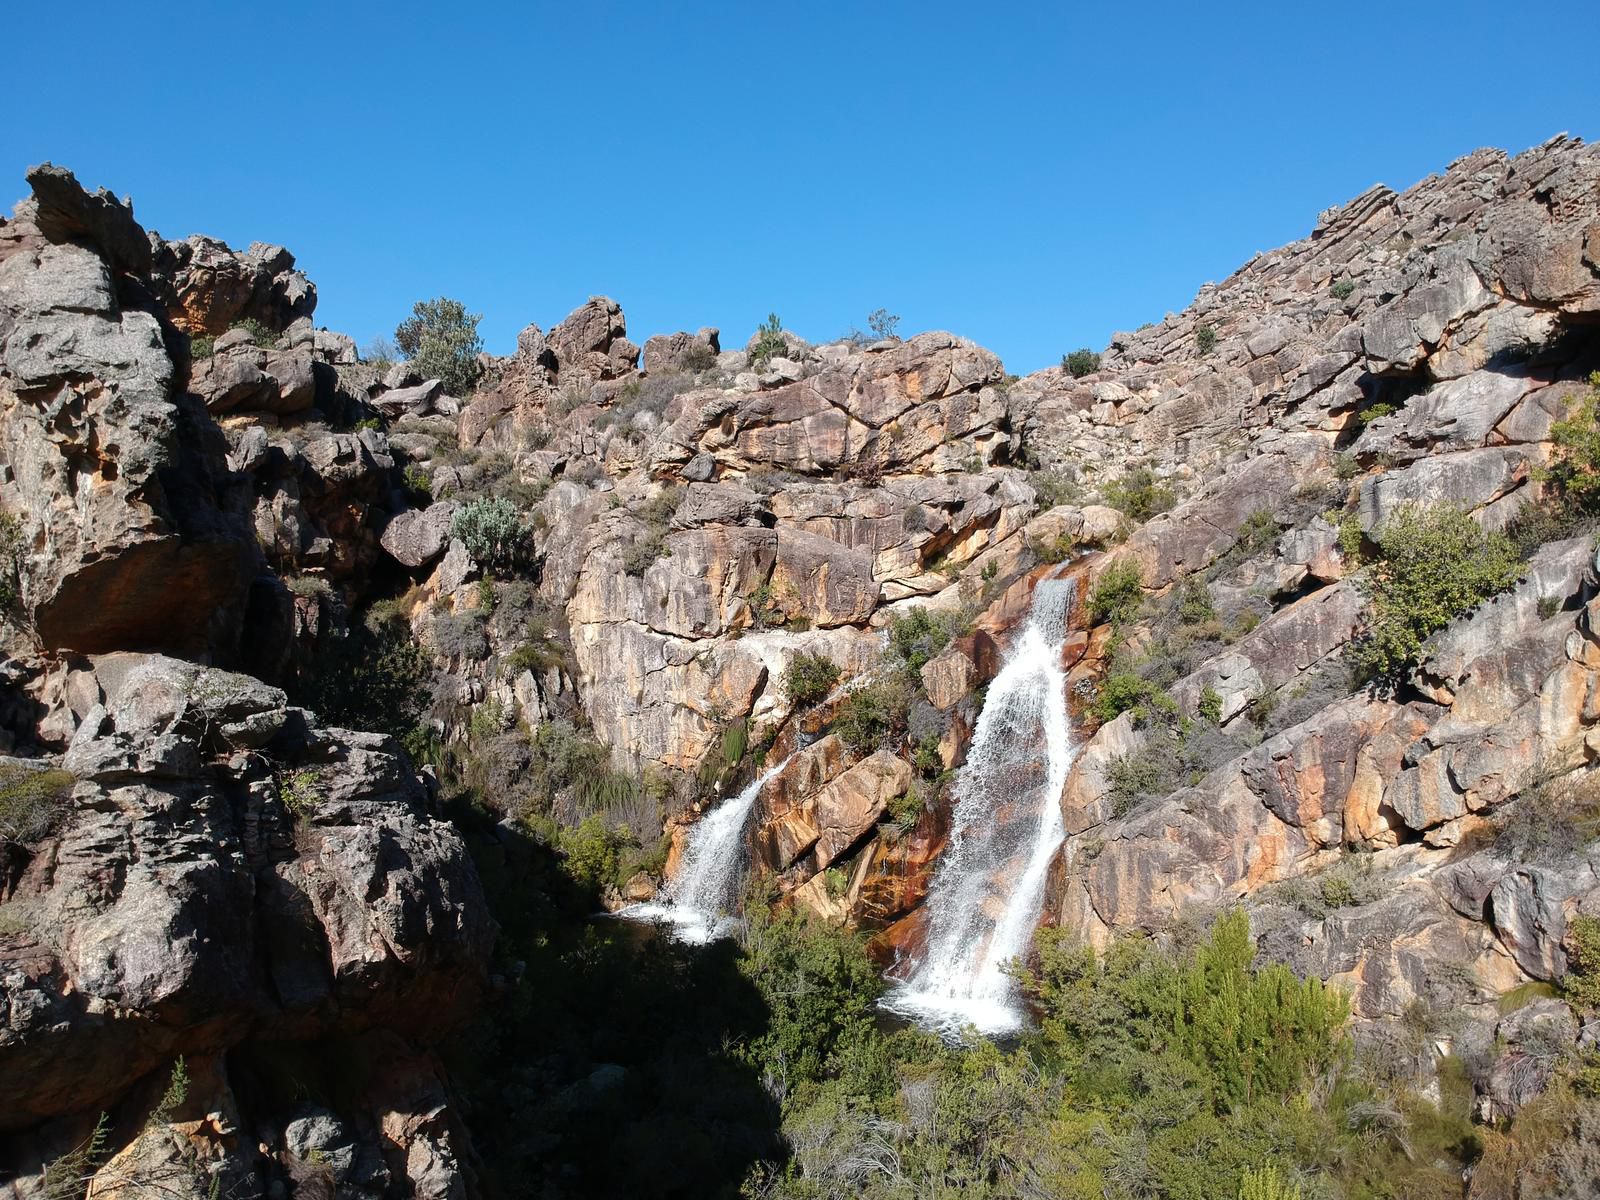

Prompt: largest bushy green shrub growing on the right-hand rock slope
[{"left": 1355, "top": 504, "right": 1522, "bottom": 685}]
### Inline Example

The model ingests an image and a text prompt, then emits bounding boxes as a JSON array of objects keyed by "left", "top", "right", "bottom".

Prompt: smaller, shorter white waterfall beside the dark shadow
[{"left": 616, "top": 758, "right": 789, "bottom": 944}]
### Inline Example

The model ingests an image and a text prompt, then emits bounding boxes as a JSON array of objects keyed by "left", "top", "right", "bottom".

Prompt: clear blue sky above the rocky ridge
[{"left": 0, "top": 0, "right": 1600, "bottom": 371}]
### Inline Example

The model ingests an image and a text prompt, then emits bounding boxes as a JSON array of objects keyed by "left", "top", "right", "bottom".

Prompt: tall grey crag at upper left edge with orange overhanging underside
[{"left": 0, "top": 163, "right": 259, "bottom": 656}]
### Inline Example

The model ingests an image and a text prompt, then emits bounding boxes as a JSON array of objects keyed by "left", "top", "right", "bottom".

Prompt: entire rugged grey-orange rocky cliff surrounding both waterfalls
[{"left": 0, "top": 131, "right": 1600, "bottom": 1195}]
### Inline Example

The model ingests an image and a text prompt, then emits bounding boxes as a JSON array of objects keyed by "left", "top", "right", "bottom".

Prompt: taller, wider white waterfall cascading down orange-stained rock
[{"left": 883, "top": 579, "right": 1075, "bottom": 1034}]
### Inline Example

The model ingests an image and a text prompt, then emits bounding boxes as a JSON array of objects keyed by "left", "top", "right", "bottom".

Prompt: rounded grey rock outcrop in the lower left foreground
[{"left": 0, "top": 654, "right": 493, "bottom": 1158}]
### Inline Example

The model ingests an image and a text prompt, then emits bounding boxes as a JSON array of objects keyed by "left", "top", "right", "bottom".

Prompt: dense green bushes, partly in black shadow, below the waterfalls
[{"left": 450, "top": 821, "right": 1523, "bottom": 1200}]
